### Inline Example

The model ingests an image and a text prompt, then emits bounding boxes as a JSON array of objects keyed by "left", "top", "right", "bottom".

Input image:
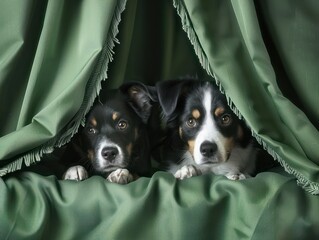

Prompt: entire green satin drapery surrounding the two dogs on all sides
[{"left": 0, "top": 0, "right": 319, "bottom": 239}]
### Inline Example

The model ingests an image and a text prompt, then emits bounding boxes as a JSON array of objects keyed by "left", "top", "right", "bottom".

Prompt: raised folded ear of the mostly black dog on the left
[{"left": 120, "top": 82, "right": 156, "bottom": 123}]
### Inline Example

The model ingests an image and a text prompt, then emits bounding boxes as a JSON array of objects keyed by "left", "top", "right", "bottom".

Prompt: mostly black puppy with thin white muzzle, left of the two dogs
[{"left": 63, "top": 83, "right": 152, "bottom": 184}]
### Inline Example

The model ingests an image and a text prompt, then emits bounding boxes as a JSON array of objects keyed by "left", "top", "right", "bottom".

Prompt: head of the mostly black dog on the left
[{"left": 81, "top": 83, "right": 151, "bottom": 175}]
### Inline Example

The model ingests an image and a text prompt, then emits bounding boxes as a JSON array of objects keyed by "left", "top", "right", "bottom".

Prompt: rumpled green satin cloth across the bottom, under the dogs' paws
[{"left": 0, "top": 172, "right": 319, "bottom": 240}]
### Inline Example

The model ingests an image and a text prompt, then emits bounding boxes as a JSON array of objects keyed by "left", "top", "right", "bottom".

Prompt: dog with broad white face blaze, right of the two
[{"left": 156, "top": 78, "right": 257, "bottom": 180}]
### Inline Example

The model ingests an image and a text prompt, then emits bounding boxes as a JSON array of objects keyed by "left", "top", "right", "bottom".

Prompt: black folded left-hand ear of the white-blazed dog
[{"left": 156, "top": 79, "right": 196, "bottom": 116}]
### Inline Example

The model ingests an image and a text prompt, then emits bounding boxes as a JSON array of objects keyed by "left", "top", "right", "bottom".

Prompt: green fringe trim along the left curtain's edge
[{"left": 0, "top": 0, "right": 127, "bottom": 177}]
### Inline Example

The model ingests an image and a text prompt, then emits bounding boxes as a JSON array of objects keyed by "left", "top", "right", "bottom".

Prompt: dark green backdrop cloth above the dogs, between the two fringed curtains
[{"left": 102, "top": 0, "right": 204, "bottom": 88}]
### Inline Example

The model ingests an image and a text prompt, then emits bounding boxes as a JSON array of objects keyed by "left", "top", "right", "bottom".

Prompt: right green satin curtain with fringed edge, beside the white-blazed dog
[{"left": 174, "top": 0, "right": 319, "bottom": 191}]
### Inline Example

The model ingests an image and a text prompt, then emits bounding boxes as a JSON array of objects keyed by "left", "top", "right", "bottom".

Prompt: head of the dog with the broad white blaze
[{"left": 156, "top": 79, "right": 248, "bottom": 164}]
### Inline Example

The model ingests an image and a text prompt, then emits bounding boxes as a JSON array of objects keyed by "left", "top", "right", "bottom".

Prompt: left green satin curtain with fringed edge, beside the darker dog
[{"left": 0, "top": 0, "right": 125, "bottom": 173}]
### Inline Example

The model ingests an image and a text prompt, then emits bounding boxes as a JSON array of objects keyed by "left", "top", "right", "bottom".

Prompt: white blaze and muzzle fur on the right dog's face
[{"left": 194, "top": 89, "right": 226, "bottom": 164}]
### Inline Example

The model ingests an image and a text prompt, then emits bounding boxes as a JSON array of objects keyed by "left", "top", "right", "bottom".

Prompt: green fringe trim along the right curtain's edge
[{"left": 173, "top": 0, "right": 319, "bottom": 195}]
